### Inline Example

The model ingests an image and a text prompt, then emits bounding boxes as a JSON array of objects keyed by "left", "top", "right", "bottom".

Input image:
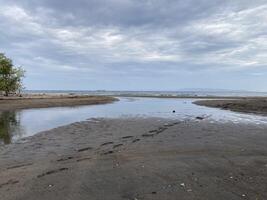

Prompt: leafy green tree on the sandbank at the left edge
[{"left": 0, "top": 53, "right": 25, "bottom": 96}]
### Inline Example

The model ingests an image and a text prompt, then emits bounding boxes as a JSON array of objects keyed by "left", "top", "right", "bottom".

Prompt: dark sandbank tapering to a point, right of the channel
[{"left": 194, "top": 97, "right": 267, "bottom": 115}]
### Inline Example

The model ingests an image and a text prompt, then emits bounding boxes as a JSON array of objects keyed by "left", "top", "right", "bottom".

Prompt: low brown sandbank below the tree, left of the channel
[{"left": 0, "top": 94, "right": 117, "bottom": 112}]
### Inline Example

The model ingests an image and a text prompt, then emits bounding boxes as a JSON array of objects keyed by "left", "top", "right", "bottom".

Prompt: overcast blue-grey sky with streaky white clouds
[{"left": 0, "top": 0, "right": 267, "bottom": 91}]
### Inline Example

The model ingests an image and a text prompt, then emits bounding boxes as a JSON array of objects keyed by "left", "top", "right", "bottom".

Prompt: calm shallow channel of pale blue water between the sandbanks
[{"left": 0, "top": 98, "right": 267, "bottom": 144}]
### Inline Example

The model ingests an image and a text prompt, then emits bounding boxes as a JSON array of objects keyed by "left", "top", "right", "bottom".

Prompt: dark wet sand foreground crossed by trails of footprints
[{"left": 0, "top": 118, "right": 267, "bottom": 200}]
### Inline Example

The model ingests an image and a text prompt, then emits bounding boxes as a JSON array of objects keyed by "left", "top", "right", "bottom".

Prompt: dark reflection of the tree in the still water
[{"left": 0, "top": 111, "right": 24, "bottom": 144}]
